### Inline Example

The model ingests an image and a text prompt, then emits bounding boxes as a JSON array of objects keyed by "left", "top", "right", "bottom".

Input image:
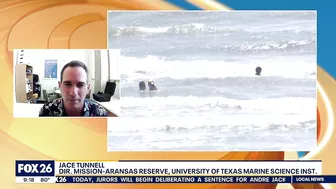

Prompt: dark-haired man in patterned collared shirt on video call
[{"left": 39, "top": 60, "right": 108, "bottom": 117}]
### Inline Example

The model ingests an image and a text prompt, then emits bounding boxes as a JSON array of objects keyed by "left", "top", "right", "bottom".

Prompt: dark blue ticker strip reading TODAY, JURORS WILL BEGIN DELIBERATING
[{"left": 56, "top": 176, "right": 292, "bottom": 183}]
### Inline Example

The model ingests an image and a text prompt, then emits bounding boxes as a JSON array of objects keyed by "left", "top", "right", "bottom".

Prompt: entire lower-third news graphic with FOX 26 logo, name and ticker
[{"left": 16, "top": 160, "right": 336, "bottom": 184}]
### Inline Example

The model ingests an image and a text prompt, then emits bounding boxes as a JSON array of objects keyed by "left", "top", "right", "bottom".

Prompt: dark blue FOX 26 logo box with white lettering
[{"left": 15, "top": 160, "right": 55, "bottom": 176}]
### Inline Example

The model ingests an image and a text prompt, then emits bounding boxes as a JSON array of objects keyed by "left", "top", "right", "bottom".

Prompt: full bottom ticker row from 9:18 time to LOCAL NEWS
[{"left": 16, "top": 175, "right": 336, "bottom": 184}]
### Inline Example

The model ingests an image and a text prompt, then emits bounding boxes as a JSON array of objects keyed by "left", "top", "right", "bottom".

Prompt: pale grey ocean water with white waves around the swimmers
[{"left": 108, "top": 11, "right": 317, "bottom": 151}]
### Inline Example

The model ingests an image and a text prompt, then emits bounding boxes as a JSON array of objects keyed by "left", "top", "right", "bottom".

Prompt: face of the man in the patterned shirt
[{"left": 58, "top": 67, "right": 90, "bottom": 109}]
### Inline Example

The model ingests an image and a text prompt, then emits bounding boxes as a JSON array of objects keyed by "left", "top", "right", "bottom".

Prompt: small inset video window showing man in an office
[{"left": 13, "top": 49, "right": 120, "bottom": 117}]
